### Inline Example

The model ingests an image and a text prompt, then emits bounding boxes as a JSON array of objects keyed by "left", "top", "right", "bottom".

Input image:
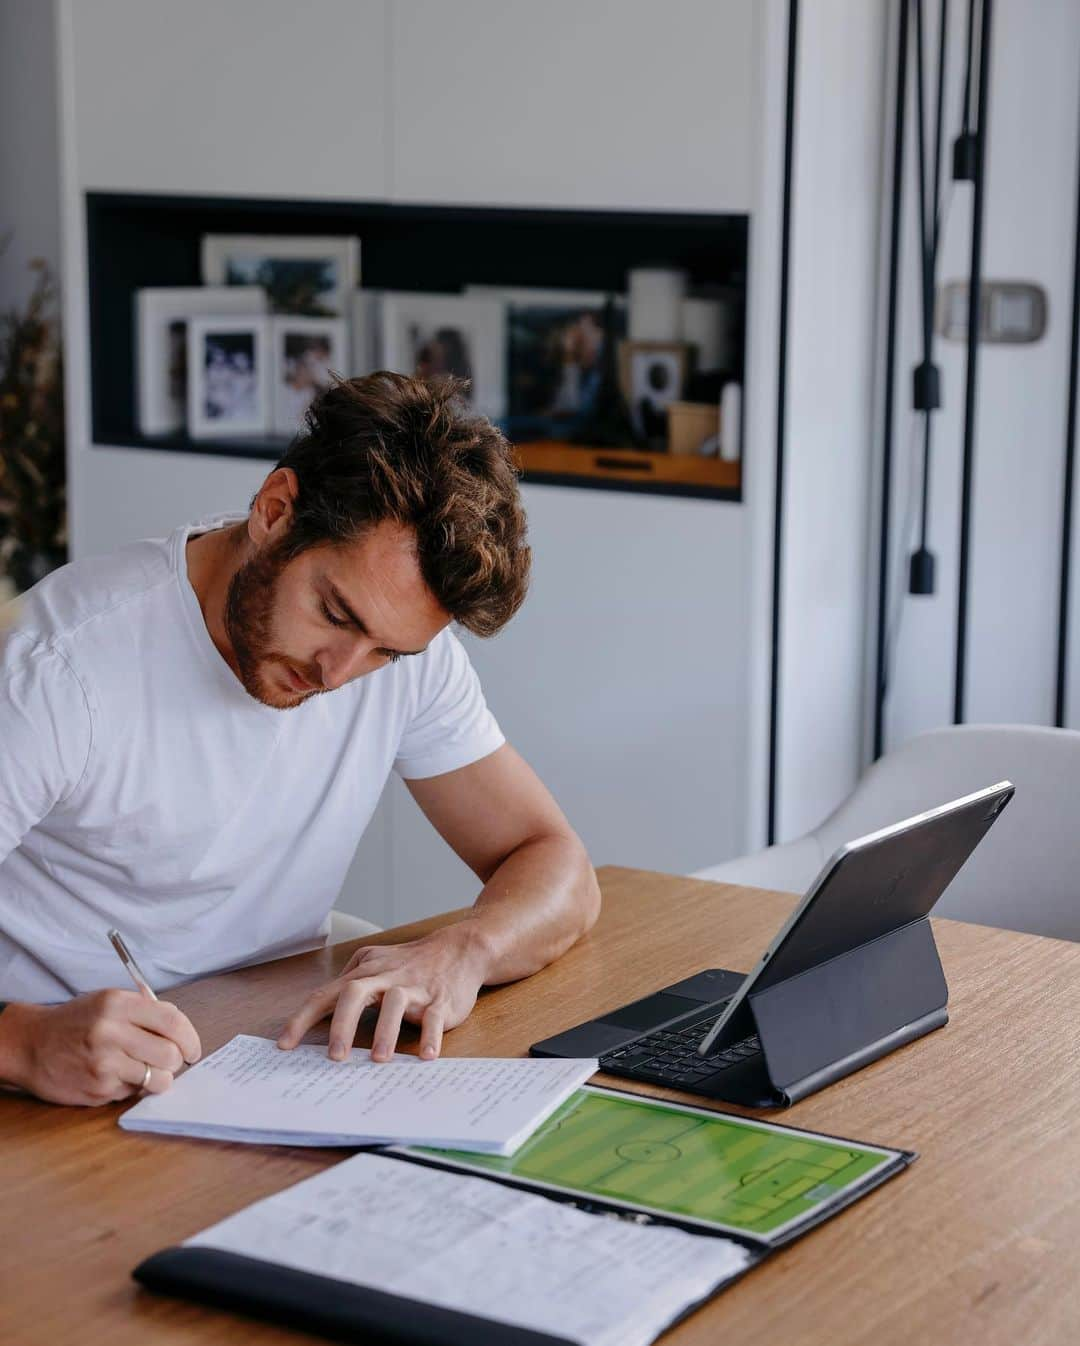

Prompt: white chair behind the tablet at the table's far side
[{"left": 694, "top": 724, "right": 1080, "bottom": 940}]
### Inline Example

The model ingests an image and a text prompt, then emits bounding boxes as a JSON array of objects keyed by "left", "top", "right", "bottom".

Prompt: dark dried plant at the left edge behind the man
[{"left": 0, "top": 258, "right": 67, "bottom": 591}]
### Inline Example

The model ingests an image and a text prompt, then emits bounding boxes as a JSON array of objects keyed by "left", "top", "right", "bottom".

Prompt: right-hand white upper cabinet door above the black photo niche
[{"left": 389, "top": 0, "right": 757, "bottom": 211}]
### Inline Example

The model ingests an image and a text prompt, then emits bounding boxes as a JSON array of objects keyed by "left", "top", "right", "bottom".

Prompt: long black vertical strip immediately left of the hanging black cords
[{"left": 874, "top": 0, "right": 909, "bottom": 760}]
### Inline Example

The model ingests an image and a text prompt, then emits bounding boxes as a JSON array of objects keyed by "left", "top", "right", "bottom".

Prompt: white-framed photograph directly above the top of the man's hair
[{"left": 381, "top": 291, "right": 506, "bottom": 419}]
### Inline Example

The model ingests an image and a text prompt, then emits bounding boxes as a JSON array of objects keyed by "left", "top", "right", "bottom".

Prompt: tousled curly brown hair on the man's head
[{"left": 269, "top": 370, "right": 532, "bottom": 635}]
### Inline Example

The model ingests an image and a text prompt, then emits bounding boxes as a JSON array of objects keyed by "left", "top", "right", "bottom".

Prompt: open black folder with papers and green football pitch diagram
[{"left": 133, "top": 1086, "right": 916, "bottom": 1346}]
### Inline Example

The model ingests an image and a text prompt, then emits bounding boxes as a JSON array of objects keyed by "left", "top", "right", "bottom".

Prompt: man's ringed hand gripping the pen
[{"left": 0, "top": 989, "right": 202, "bottom": 1106}]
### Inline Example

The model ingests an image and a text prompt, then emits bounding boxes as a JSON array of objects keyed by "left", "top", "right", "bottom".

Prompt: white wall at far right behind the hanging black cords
[{"left": 886, "top": 0, "right": 1080, "bottom": 747}]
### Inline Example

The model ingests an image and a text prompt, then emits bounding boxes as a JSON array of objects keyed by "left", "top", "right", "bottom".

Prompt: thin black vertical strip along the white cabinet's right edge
[{"left": 768, "top": 0, "right": 799, "bottom": 845}]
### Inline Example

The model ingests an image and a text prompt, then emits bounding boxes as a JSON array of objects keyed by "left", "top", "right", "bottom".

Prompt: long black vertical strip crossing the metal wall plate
[{"left": 952, "top": 0, "right": 994, "bottom": 724}]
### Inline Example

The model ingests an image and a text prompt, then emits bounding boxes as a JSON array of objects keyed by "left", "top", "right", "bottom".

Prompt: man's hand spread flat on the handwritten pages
[{"left": 277, "top": 921, "right": 487, "bottom": 1061}]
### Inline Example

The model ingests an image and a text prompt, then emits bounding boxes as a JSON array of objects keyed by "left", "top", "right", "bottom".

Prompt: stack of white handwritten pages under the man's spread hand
[{"left": 120, "top": 1035, "right": 598, "bottom": 1155}]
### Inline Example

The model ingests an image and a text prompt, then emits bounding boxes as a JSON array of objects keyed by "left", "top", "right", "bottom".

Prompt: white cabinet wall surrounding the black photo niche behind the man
[{"left": 59, "top": 0, "right": 777, "bottom": 923}]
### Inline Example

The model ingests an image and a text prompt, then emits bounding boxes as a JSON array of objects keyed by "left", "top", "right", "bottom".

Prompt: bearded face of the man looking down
[{"left": 225, "top": 522, "right": 450, "bottom": 711}]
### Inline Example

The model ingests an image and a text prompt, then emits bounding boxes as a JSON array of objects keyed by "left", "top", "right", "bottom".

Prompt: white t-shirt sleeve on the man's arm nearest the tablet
[{"left": 395, "top": 630, "right": 506, "bottom": 781}]
